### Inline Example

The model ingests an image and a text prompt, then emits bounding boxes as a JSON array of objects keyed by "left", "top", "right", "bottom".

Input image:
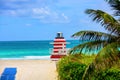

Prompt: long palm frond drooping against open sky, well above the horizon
[{"left": 85, "top": 9, "right": 120, "bottom": 35}]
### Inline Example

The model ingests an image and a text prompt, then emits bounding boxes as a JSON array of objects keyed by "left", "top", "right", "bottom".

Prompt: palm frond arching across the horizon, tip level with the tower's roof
[{"left": 72, "top": 31, "right": 117, "bottom": 41}]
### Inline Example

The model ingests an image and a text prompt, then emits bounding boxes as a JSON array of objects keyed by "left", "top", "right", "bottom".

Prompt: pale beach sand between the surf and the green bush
[{"left": 0, "top": 60, "right": 57, "bottom": 80}]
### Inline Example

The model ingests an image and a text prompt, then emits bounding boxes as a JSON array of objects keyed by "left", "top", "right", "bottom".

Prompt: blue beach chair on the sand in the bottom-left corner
[{"left": 0, "top": 68, "right": 17, "bottom": 80}]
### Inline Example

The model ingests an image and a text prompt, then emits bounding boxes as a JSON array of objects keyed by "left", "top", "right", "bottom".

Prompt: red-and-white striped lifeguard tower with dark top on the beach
[{"left": 50, "top": 32, "right": 68, "bottom": 61}]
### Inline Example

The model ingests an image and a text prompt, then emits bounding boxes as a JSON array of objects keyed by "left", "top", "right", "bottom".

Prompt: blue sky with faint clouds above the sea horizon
[{"left": 0, "top": 0, "right": 111, "bottom": 41}]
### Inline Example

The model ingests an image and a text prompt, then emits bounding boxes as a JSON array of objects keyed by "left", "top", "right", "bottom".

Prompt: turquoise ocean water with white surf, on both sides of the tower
[{"left": 0, "top": 40, "right": 80, "bottom": 59}]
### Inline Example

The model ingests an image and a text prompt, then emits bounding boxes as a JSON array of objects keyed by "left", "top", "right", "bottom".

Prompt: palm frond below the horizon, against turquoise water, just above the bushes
[{"left": 69, "top": 41, "right": 106, "bottom": 54}]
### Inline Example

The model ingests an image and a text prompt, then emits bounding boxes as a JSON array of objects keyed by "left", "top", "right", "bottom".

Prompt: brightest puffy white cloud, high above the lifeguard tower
[{"left": 32, "top": 7, "right": 69, "bottom": 23}]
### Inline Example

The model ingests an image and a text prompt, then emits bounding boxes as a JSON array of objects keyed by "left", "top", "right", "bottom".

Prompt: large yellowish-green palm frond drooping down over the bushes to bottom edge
[{"left": 83, "top": 42, "right": 120, "bottom": 80}]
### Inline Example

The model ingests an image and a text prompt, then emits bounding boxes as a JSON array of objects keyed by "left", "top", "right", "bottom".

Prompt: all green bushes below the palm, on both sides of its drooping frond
[{"left": 57, "top": 54, "right": 120, "bottom": 80}]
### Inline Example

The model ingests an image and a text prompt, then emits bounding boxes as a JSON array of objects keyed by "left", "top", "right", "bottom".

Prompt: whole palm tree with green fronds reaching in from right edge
[{"left": 70, "top": 0, "right": 120, "bottom": 80}]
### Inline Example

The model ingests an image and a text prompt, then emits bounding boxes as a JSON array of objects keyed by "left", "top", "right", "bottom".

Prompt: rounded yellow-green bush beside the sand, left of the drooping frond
[{"left": 57, "top": 54, "right": 95, "bottom": 80}]
